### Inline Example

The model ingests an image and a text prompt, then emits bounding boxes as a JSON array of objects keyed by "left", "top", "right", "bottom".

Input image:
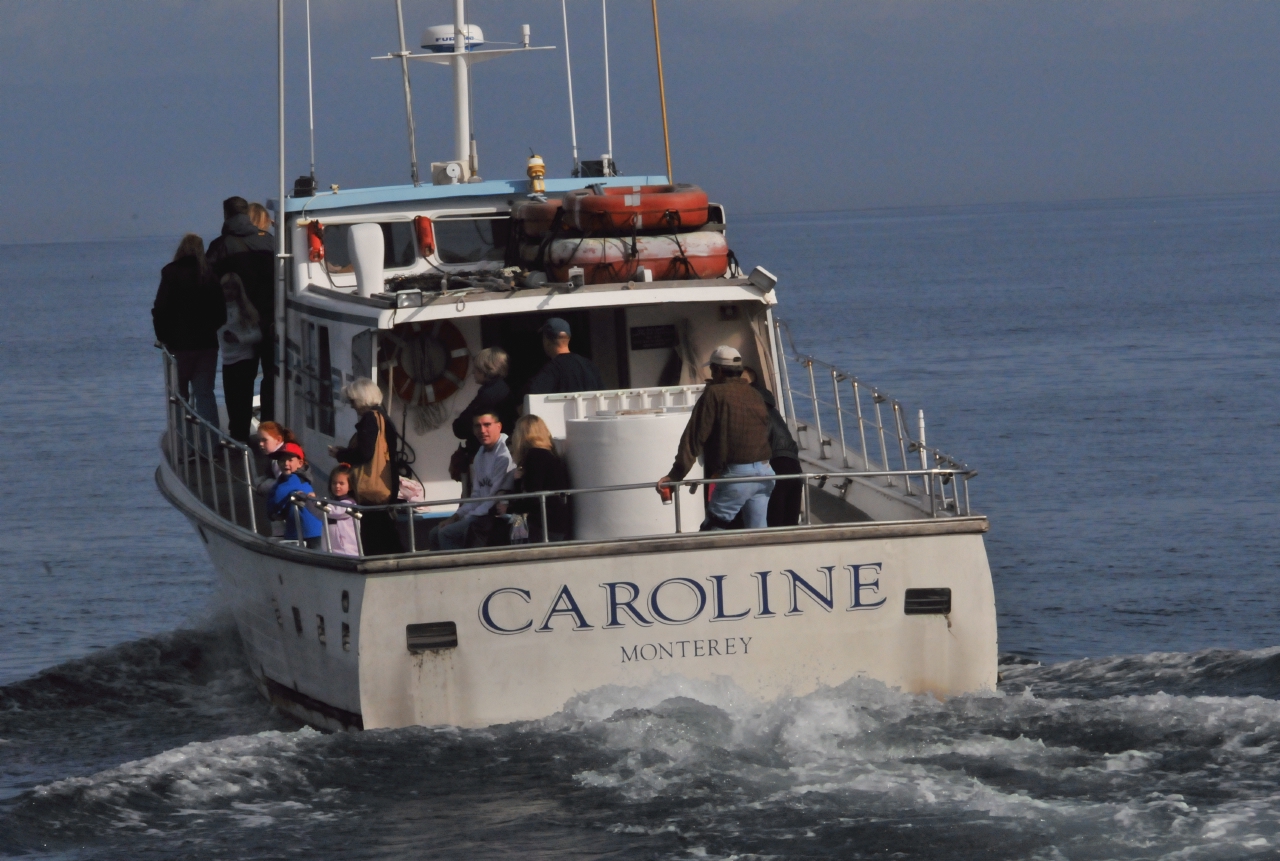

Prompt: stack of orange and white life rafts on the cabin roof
[{"left": 511, "top": 184, "right": 731, "bottom": 284}]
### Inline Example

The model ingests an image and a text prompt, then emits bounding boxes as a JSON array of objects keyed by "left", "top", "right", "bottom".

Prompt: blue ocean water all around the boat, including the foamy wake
[{"left": 0, "top": 194, "right": 1280, "bottom": 861}]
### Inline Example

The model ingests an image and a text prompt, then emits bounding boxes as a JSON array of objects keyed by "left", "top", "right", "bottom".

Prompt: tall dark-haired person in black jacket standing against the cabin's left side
[{"left": 209, "top": 197, "right": 275, "bottom": 421}]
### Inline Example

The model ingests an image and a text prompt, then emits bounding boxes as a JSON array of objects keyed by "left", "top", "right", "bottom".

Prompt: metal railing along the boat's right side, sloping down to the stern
[{"left": 774, "top": 320, "right": 978, "bottom": 513}]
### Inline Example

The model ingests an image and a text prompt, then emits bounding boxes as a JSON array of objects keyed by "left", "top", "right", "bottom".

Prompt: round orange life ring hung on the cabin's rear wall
[{"left": 384, "top": 320, "right": 471, "bottom": 407}]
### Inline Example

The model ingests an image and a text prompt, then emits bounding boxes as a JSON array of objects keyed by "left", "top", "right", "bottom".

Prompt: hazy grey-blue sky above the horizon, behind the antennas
[{"left": 0, "top": 0, "right": 1280, "bottom": 243}]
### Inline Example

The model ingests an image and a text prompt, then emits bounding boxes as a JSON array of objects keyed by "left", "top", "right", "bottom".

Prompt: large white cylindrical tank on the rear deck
[{"left": 564, "top": 407, "right": 703, "bottom": 540}]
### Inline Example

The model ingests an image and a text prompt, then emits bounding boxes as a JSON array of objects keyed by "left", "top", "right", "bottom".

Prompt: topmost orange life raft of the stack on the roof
[{"left": 564, "top": 183, "right": 708, "bottom": 233}]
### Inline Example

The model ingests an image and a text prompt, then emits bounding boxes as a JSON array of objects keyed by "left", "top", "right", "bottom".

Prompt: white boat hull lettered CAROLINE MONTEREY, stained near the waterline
[{"left": 157, "top": 452, "right": 997, "bottom": 729}]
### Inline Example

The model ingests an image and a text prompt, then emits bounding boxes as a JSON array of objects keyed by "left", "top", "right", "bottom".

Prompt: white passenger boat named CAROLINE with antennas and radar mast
[{"left": 155, "top": 0, "right": 997, "bottom": 731}]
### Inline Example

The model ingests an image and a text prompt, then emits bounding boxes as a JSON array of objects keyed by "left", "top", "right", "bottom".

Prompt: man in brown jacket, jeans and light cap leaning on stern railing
[{"left": 658, "top": 347, "right": 773, "bottom": 531}]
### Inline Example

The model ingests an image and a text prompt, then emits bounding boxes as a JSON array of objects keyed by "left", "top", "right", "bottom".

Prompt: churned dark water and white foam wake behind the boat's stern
[{"left": 0, "top": 629, "right": 1280, "bottom": 860}]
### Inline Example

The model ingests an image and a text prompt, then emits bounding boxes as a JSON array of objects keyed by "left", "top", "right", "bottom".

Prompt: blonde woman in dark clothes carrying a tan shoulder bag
[{"left": 329, "top": 377, "right": 404, "bottom": 555}]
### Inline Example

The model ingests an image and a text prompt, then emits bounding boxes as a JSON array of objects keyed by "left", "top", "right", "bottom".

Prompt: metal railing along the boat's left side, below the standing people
[{"left": 160, "top": 349, "right": 262, "bottom": 532}]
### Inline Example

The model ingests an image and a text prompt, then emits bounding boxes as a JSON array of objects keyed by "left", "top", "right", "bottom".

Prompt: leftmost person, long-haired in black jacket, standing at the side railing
[{"left": 151, "top": 233, "right": 227, "bottom": 427}]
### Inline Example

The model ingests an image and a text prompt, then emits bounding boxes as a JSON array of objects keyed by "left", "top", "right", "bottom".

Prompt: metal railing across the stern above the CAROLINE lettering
[{"left": 280, "top": 468, "right": 969, "bottom": 555}]
